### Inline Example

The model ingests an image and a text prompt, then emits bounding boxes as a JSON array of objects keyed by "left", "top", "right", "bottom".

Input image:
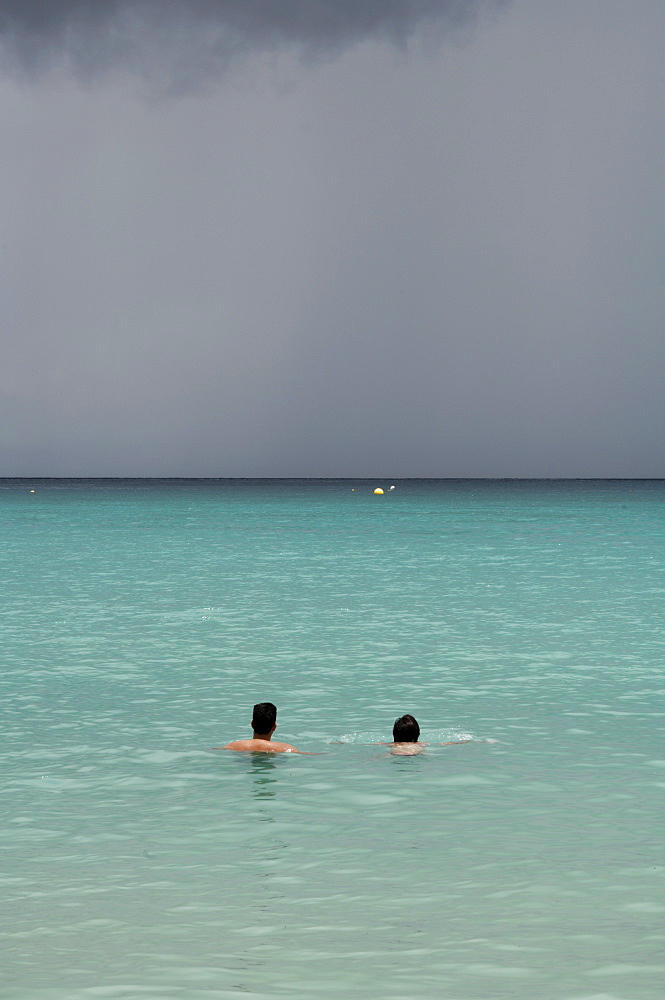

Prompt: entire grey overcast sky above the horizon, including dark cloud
[{"left": 0, "top": 0, "right": 665, "bottom": 478}]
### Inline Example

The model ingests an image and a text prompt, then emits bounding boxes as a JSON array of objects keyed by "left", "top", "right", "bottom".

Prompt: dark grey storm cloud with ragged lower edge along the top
[{"left": 0, "top": 0, "right": 506, "bottom": 77}]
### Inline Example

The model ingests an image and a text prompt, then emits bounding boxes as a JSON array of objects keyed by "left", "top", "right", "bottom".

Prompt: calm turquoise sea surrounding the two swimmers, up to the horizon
[{"left": 0, "top": 479, "right": 665, "bottom": 1000}]
